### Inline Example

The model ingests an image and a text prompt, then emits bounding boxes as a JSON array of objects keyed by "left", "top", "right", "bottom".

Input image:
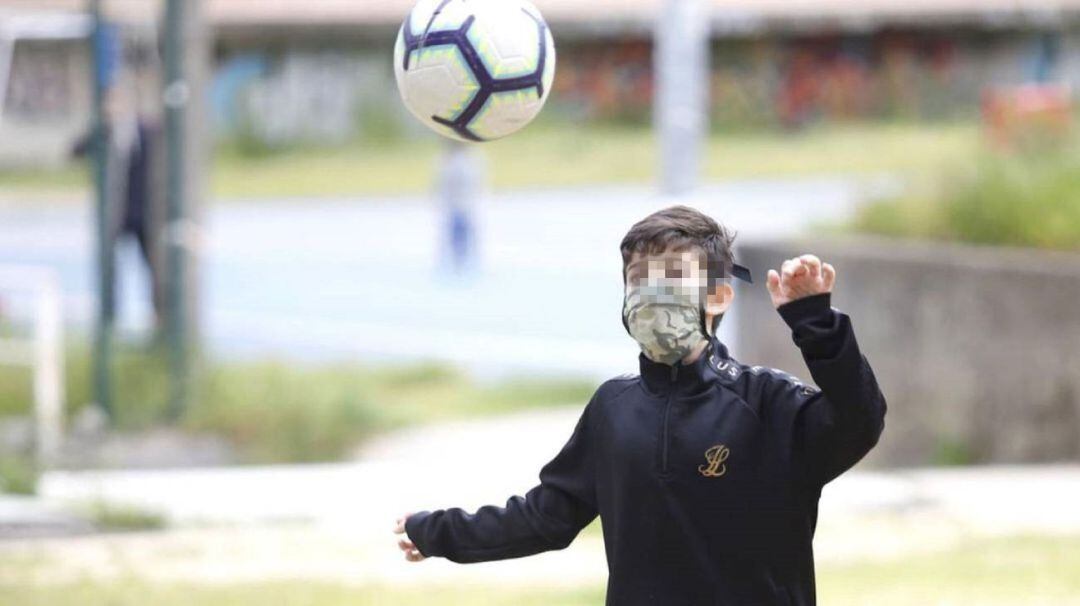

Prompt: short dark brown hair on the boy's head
[{"left": 619, "top": 205, "right": 735, "bottom": 288}]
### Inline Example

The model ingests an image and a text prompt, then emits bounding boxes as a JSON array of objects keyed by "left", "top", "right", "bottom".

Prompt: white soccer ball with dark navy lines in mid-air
[{"left": 394, "top": 0, "right": 555, "bottom": 142}]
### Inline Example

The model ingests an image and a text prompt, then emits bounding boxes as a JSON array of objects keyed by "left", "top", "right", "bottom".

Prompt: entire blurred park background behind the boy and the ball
[{"left": 0, "top": 0, "right": 1080, "bottom": 606}]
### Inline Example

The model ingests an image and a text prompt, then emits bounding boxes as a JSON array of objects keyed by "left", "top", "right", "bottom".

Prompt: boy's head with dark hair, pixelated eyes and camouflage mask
[{"left": 619, "top": 206, "right": 748, "bottom": 364}]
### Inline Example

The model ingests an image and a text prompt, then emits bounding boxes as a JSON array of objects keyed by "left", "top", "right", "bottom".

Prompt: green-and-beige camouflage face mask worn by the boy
[{"left": 622, "top": 272, "right": 706, "bottom": 365}]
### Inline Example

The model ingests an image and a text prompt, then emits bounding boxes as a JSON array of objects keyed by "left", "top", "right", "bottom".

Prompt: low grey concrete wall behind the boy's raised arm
[{"left": 733, "top": 239, "right": 1080, "bottom": 466}]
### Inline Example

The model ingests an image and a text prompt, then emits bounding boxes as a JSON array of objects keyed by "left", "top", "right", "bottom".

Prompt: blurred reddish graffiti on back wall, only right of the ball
[{"left": 552, "top": 30, "right": 1080, "bottom": 127}]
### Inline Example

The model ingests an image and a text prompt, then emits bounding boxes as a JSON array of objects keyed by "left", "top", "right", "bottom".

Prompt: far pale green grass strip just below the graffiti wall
[{"left": 0, "top": 122, "right": 980, "bottom": 199}]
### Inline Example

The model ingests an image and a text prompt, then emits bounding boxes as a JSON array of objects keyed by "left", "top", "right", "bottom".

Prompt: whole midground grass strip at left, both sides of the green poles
[{"left": 0, "top": 346, "right": 595, "bottom": 464}]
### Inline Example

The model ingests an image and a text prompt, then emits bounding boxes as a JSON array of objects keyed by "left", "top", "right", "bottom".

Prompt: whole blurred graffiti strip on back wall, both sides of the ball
[{"left": 200, "top": 30, "right": 1080, "bottom": 144}]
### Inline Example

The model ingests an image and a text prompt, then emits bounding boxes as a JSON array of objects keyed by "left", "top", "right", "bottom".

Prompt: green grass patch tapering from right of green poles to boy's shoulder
[{"left": 186, "top": 362, "right": 595, "bottom": 462}]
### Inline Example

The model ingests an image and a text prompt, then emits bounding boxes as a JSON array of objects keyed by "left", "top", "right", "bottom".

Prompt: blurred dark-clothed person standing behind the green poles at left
[{"left": 72, "top": 90, "right": 162, "bottom": 326}]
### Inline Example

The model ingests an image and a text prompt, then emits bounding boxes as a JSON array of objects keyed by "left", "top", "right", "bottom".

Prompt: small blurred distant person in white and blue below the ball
[{"left": 437, "top": 143, "right": 485, "bottom": 275}]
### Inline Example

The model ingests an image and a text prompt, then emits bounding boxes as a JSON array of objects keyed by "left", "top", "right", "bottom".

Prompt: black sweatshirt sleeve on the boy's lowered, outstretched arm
[{"left": 405, "top": 395, "right": 597, "bottom": 564}]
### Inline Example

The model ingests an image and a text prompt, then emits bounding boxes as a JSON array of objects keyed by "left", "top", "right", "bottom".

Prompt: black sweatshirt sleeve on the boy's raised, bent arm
[{"left": 778, "top": 293, "right": 886, "bottom": 484}]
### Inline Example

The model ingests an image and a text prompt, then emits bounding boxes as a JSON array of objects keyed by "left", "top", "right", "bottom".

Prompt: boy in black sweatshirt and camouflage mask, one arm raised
[{"left": 395, "top": 206, "right": 886, "bottom": 606}]
